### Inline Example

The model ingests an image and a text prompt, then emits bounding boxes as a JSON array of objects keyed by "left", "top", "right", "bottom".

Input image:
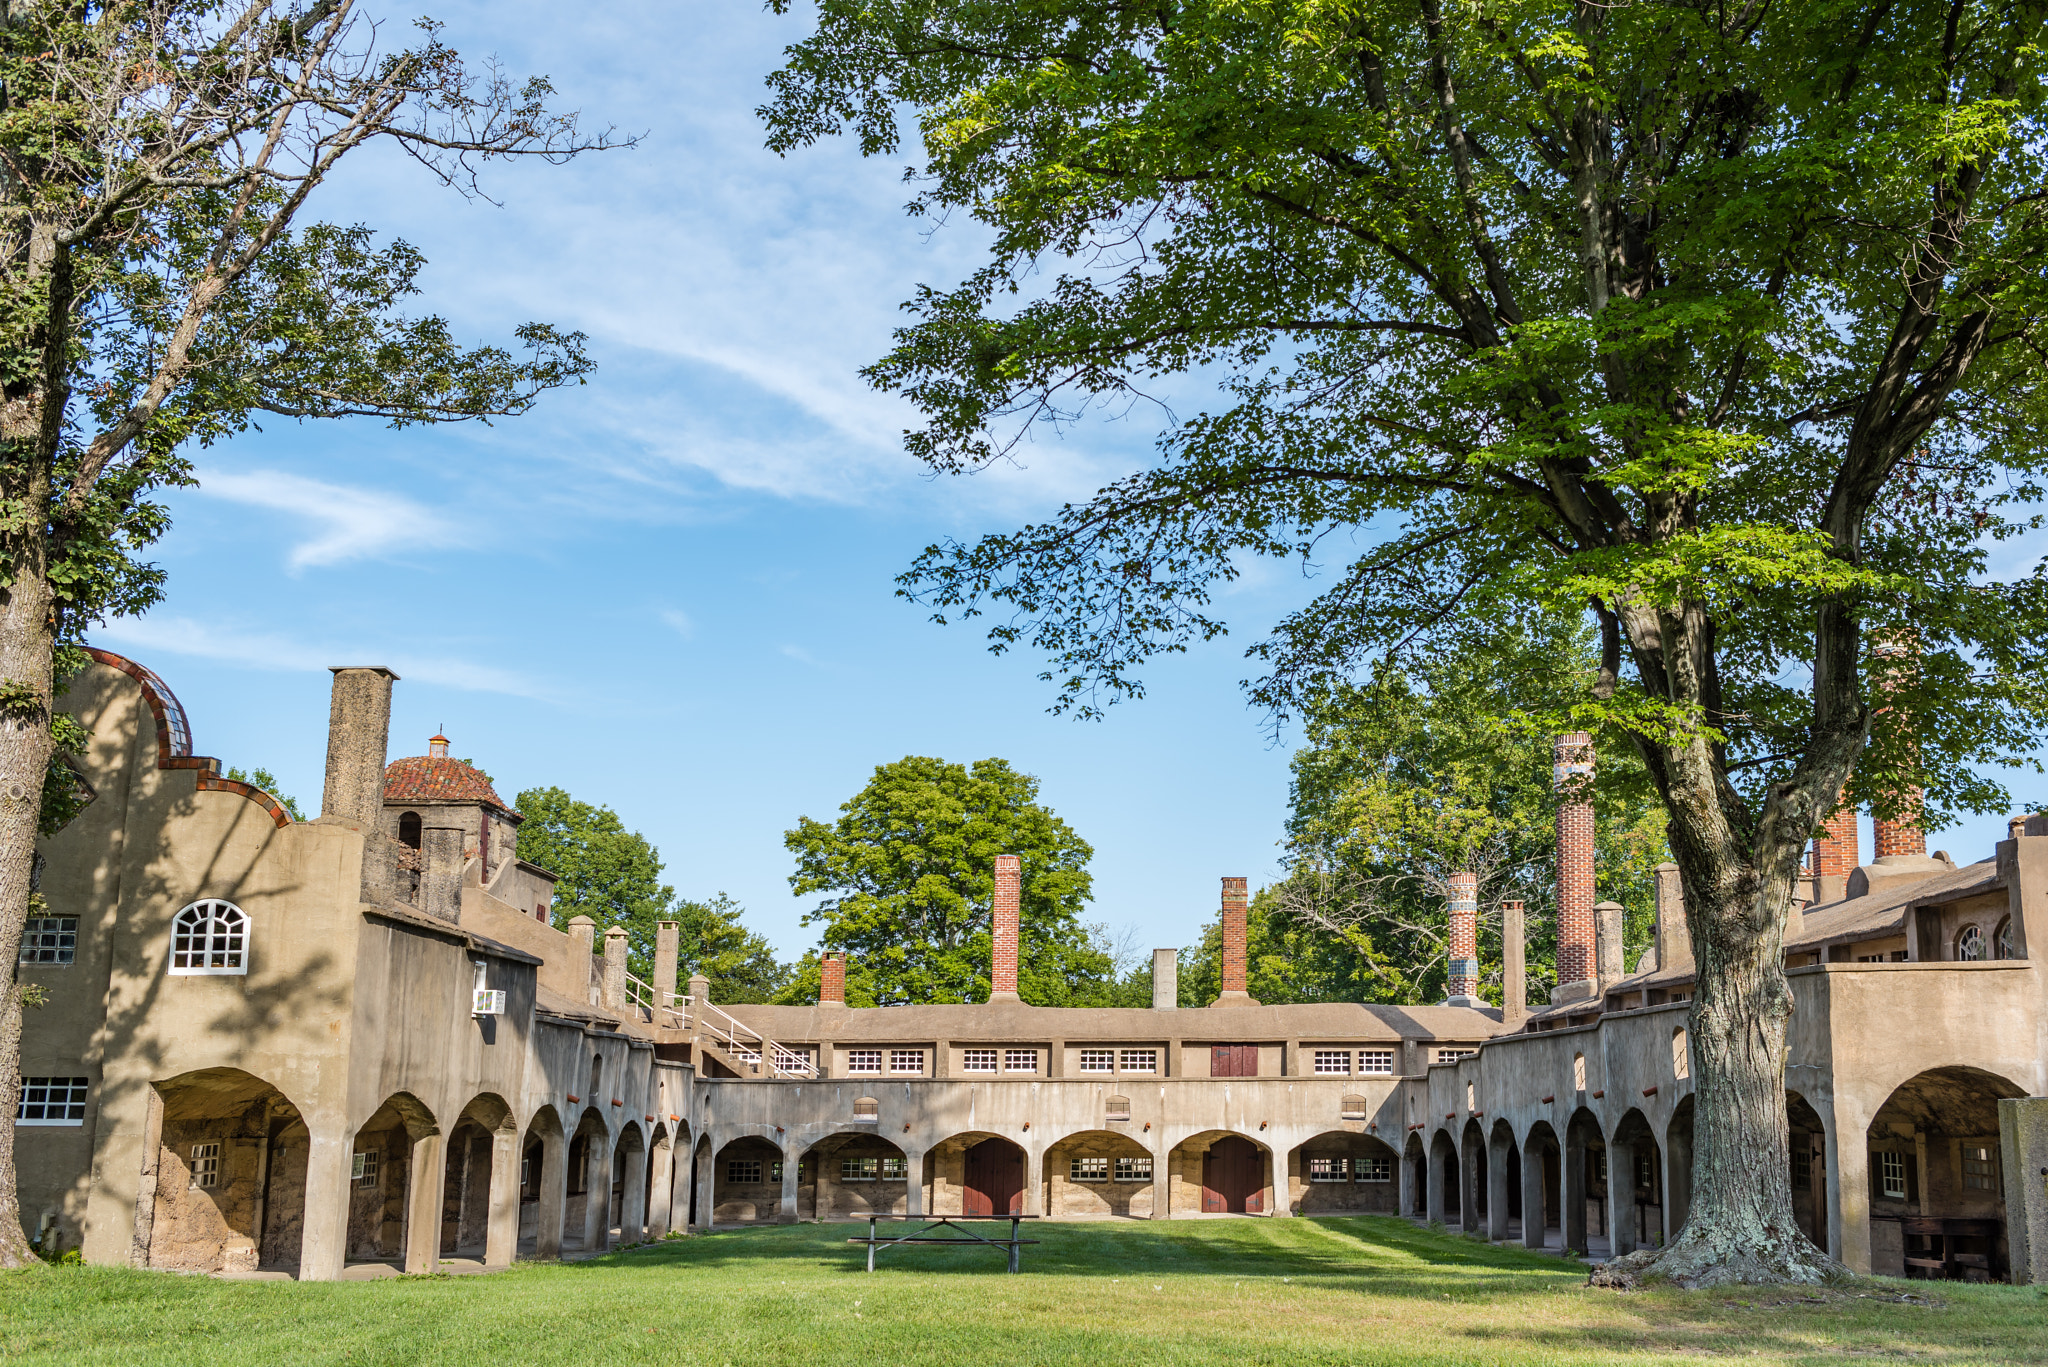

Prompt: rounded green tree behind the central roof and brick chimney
[{"left": 784, "top": 754, "right": 1110, "bottom": 1006}]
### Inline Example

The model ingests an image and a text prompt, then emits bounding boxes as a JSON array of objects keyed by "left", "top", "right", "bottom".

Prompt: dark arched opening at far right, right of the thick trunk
[{"left": 1868, "top": 1068, "right": 2025, "bottom": 1281}]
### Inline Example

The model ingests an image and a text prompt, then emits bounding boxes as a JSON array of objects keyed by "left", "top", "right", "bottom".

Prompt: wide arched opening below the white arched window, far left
[{"left": 137, "top": 1068, "right": 311, "bottom": 1273}]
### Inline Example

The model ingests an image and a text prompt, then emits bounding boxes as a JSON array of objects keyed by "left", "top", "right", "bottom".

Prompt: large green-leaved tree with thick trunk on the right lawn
[{"left": 764, "top": 0, "right": 2048, "bottom": 1283}]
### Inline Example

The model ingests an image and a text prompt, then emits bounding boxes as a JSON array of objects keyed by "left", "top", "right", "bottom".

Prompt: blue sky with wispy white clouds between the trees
[{"left": 83, "top": 0, "right": 2031, "bottom": 953}]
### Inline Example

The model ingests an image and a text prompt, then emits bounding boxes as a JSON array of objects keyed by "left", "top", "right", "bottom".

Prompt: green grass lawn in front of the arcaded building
[{"left": 0, "top": 1217, "right": 2048, "bottom": 1367}]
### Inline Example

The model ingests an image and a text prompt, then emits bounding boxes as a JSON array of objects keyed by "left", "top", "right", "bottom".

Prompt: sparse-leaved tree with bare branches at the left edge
[{"left": 0, "top": 0, "right": 608, "bottom": 1267}]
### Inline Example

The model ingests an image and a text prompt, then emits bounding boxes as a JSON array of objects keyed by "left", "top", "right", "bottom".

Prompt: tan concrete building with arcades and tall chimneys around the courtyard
[{"left": 16, "top": 652, "right": 2048, "bottom": 1279}]
